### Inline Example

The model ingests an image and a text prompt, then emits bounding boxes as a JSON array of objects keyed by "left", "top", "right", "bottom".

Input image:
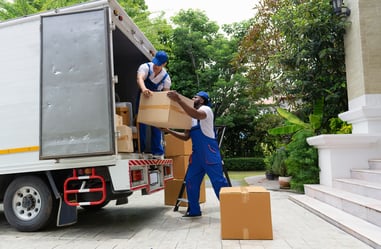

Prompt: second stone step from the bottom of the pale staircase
[{"left": 304, "top": 184, "right": 381, "bottom": 228}]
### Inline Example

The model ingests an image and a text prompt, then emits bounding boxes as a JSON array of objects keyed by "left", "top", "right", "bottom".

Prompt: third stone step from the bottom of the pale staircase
[{"left": 333, "top": 178, "right": 381, "bottom": 200}]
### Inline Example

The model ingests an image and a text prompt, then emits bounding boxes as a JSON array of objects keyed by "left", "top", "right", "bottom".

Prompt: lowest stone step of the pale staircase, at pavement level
[{"left": 289, "top": 195, "right": 381, "bottom": 249}]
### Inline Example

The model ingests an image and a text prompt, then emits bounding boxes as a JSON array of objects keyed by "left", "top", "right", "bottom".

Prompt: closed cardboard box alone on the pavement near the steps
[{"left": 220, "top": 186, "right": 273, "bottom": 240}]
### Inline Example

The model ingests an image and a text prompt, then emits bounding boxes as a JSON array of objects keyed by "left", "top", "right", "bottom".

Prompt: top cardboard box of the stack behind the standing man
[{"left": 164, "top": 134, "right": 192, "bottom": 157}]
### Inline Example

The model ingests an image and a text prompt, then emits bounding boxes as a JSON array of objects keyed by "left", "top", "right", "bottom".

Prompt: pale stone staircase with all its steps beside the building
[{"left": 290, "top": 160, "right": 381, "bottom": 249}]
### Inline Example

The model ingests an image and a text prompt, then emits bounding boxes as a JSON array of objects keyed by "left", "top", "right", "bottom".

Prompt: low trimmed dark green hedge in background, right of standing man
[{"left": 224, "top": 157, "right": 265, "bottom": 171}]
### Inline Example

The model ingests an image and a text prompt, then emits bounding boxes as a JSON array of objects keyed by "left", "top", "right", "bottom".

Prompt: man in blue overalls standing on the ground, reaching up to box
[{"left": 165, "top": 91, "right": 228, "bottom": 217}]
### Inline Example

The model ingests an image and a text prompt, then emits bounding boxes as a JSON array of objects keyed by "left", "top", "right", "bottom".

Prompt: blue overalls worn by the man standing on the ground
[{"left": 185, "top": 120, "right": 228, "bottom": 215}]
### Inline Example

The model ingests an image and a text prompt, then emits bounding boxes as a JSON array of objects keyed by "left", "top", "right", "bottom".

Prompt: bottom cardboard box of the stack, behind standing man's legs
[{"left": 164, "top": 179, "right": 206, "bottom": 207}]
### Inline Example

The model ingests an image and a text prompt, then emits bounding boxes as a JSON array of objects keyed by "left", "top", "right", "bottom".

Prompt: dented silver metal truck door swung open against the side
[{"left": 40, "top": 8, "right": 115, "bottom": 159}]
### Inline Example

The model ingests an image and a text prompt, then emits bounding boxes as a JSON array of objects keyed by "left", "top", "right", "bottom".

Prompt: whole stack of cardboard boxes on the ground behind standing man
[{"left": 164, "top": 134, "right": 206, "bottom": 207}]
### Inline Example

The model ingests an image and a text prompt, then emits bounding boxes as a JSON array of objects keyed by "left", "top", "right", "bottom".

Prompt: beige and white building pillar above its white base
[{"left": 345, "top": 0, "right": 381, "bottom": 110}]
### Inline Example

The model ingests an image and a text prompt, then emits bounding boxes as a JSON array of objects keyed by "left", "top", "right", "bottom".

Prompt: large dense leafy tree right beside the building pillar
[{"left": 272, "top": 0, "right": 348, "bottom": 124}]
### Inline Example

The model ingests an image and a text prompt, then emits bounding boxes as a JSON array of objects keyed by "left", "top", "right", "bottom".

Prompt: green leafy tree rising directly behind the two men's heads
[{"left": 168, "top": 9, "right": 219, "bottom": 97}]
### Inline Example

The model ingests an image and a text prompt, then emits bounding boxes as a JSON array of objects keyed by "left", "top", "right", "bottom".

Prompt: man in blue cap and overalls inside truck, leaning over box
[{"left": 136, "top": 51, "right": 171, "bottom": 159}]
